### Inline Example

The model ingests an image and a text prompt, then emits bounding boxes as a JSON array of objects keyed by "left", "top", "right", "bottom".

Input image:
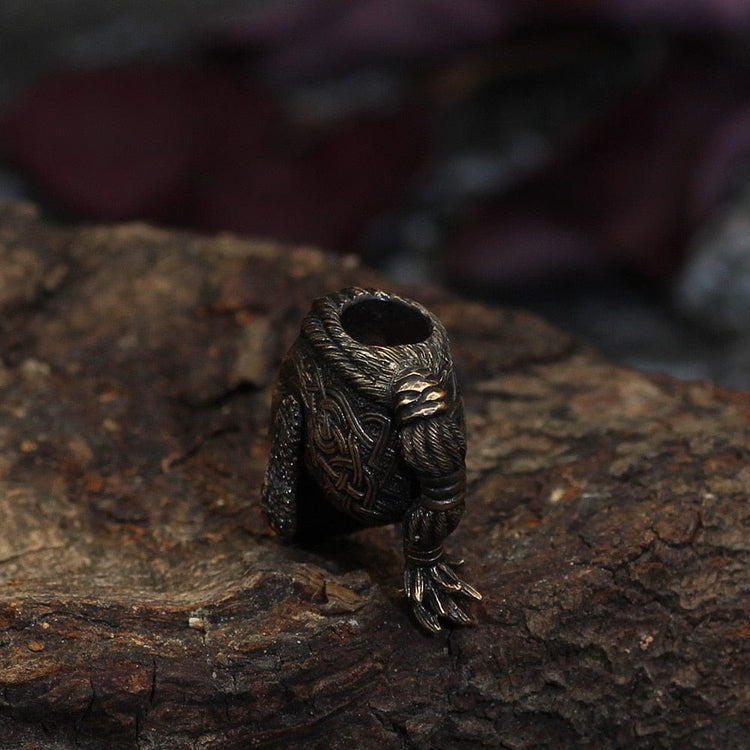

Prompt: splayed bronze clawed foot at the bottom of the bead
[{"left": 404, "top": 560, "right": 482, "bottom": 633}]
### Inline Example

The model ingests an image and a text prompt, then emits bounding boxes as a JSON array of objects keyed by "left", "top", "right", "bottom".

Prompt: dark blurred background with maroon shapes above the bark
[{"left": 0, "top": 0, "right": 750, "bottom": 389}]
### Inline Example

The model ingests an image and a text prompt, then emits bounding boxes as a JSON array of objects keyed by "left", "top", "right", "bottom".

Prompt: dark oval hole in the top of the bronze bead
[{"left": 341, "top": 299, "right": 432, "bottom": 346}]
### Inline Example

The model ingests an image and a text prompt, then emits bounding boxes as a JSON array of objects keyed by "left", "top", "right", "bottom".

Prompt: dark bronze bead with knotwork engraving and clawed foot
[{"left": 262, "top": 288, "right": 481, "bottom": 631}]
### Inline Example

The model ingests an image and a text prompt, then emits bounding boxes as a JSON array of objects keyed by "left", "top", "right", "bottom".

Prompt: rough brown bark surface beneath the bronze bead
[{"left": 0, "top": 206, "right": 750, "bottom": 750}]
